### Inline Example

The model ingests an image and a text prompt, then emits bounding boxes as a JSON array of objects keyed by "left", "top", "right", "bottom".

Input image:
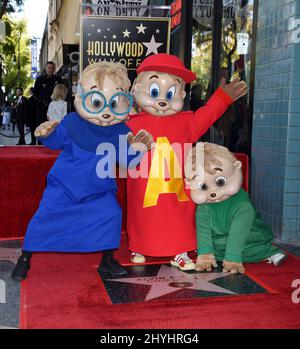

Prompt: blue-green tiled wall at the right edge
[{"left": 251, "top": 0, "right": 300, "bottom": 241}]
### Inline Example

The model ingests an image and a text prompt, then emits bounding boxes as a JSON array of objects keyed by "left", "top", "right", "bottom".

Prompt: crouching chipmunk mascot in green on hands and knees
[{"left": 185, "top": 143, "right": 286, "bottom": 273}]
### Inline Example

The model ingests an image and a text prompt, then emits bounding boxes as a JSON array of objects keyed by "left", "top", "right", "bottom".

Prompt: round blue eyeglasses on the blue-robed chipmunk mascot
[{"left": 80, "top": 91, "right": 133, "bottom": 116}]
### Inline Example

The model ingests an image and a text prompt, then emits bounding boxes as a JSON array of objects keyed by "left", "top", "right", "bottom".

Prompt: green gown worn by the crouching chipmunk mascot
[{"left": 196, "top": 189, "right": 284, "bottom": 263}]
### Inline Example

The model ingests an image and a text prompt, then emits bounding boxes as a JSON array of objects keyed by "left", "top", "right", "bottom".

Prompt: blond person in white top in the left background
[{"left": 47, "top": 84, "right": 68, "bottom": 122}]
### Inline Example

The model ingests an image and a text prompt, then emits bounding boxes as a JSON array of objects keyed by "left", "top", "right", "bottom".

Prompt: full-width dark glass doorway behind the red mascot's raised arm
[{"left": 191, "top": 0, "right": 257, "bottom": 157}]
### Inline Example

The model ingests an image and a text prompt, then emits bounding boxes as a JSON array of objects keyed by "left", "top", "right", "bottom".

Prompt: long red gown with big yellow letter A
[{"left": 127, "top": 88, "right": 232, "bottom": 257}]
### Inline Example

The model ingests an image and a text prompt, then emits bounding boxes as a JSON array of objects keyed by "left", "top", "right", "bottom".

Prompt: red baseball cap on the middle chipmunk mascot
[{"left": 137, "top": 53, "right": 197, "bottom": 83}]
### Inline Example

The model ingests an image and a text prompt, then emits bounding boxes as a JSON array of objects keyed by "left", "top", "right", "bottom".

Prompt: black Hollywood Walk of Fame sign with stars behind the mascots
[{"left": 80, "top": 16, "right": 170, "bottom": 71}]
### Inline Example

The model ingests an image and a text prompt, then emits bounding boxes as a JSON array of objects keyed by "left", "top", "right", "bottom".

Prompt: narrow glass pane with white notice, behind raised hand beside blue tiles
[{"left": 219, "top": 0, "right": 254, "bottom": 155}]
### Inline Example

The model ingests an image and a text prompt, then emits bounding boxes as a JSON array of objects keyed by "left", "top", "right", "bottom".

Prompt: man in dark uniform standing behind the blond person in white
[{"left": 34, "top": 61, "right": 61, "bottom": 126}]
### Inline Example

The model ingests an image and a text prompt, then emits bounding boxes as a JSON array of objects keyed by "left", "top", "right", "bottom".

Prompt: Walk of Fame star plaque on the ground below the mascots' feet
[{"left": 100, "top": 264, "right": 268, "bottom": 304}]
